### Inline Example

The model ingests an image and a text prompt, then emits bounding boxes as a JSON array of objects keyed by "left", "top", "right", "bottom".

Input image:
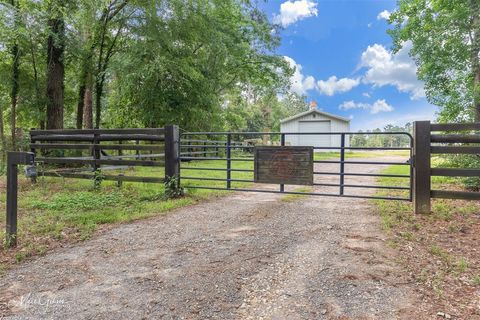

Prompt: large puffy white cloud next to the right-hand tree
[{"left": 360, "top": 42, "right": 425, "bottom": 100}]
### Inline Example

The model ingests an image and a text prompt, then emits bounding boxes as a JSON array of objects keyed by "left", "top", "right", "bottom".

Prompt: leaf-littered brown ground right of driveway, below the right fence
[{"left": 386, "top": 196, "right": 480, "bottom": 319}]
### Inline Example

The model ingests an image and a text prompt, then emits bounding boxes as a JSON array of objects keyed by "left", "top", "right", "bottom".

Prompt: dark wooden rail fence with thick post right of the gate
[{"left": 413, "top": 121, "right": 480, "bottom": 213}]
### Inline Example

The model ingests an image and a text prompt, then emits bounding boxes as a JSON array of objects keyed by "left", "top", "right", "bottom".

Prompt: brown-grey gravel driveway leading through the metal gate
[{"left": 0, "top": 157, "right": 414, "bottom": 320}]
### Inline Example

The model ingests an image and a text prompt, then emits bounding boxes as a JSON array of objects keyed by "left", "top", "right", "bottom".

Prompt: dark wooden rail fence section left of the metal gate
[{"left": 30, "top": 126, "right": 178, "bottom": 183}]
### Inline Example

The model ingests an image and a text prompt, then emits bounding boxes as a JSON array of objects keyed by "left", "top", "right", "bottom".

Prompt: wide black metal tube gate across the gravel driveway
[{"left": 180, "top": 132, "right": 413, "bottom": 201}]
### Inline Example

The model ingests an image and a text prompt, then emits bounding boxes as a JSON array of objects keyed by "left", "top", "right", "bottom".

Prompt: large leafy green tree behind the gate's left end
[{"left": 108, "top": 0, "right": 288, "bottom": 130}]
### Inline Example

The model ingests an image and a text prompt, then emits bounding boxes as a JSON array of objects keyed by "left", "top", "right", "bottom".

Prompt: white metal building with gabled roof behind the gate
[{"left": 280, "top": 109, "right": 350, "bottom": 147}]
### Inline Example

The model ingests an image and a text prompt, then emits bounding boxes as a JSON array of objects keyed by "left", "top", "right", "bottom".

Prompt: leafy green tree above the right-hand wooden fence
[{"left": 390, "top": 0, "right": 480, "bottom": 121}]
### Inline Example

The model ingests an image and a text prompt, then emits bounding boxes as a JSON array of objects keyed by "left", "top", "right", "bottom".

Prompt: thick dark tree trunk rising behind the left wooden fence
[{"left": 47, "top": 3, "right": 65, "bottom": 129}]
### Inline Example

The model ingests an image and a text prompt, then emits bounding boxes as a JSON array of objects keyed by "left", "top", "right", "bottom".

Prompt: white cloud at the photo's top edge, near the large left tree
[{"left": 273, "top": 0, "right": 318, "bottom": 27}]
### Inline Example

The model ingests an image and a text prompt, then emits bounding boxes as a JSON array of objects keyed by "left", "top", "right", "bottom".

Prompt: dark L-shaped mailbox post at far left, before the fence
[{"left": 6, "top": 152, "right": 35, "bottom": 247}]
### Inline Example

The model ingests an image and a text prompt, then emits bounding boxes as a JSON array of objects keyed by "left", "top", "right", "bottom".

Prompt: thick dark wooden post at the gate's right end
[{"left": 413, "top": 121, "right": 431, "bottom": 213}]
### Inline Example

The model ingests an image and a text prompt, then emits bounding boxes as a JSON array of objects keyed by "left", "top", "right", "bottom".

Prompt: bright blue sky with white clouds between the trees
[{"left": 262, "top": 0, "right": 438, "bottom": 130}]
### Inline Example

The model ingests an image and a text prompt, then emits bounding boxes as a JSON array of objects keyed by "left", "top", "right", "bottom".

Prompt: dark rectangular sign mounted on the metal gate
[{"left": 254, "top": 146, "right": 313, "bottom": 185}]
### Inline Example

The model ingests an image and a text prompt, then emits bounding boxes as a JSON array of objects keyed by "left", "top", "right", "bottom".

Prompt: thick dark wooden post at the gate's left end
[{"left": 165, "top": 125, "right": 180, "bottom": 182}]
